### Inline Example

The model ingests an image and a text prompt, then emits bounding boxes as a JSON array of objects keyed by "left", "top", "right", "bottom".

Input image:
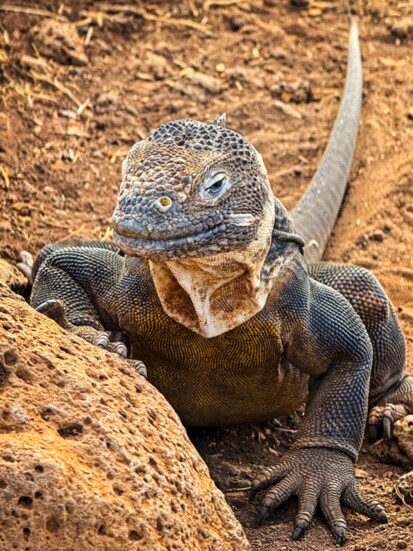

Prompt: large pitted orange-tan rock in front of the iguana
[{"left": 0, "top": 283, "right": 250, "bottom": 551}]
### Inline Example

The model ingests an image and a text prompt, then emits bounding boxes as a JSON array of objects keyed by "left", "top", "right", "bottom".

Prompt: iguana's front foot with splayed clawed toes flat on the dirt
[{"left": 251, "top": 448, "right": 387, "bottom": 545}]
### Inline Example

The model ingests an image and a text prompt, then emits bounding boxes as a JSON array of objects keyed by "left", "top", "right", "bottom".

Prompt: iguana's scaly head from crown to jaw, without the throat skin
[{"left": 113, "top": 117, "right": 273, "bottom": 259}]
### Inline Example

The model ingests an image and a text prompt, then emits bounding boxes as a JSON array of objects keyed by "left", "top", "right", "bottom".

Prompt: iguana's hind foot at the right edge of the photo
[{"left": 368, "top": 375, "right": 413, "bottom": 442}]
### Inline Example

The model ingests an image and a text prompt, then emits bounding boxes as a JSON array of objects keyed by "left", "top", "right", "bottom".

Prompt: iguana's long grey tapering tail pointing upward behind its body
[{"left": 291, "top": 20, "right": 363, "bottom": 262}]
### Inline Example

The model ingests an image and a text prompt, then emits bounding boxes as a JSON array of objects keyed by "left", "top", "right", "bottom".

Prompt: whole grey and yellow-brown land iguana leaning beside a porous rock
[{"left": 31, "top": 22, "right": 413, "bottom": 544}]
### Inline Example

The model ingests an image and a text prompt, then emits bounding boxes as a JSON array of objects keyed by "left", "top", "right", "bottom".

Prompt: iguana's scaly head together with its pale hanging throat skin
[{"left": 113, "top": 117, "right": 297, "bottom": 337}]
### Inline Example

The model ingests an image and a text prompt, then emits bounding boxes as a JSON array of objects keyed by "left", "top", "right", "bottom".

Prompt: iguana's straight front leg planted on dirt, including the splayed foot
[{"left": 252, "top": 280, "right": 387, "bottom": 544}]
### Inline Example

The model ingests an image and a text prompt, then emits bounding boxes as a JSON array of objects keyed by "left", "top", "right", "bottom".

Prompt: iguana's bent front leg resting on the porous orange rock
[{"left": 30, "top": 247, "right": 146, "bottom": 377}]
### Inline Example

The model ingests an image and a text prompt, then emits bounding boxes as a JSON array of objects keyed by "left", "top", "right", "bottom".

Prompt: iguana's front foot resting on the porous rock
[{"left": 36, "top": 299, "right": 147, "bottom": 378}]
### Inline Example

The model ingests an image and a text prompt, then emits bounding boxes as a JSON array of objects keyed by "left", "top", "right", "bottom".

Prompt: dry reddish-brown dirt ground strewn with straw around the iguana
[{"left": 0, "top": 0, "right": 413, "bottom": 551}]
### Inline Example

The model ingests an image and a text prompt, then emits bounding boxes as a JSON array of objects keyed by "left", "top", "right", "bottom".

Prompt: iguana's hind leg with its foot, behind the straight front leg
[{"left": 309, "top": 262, "right": 413, "bottom": 440}]
